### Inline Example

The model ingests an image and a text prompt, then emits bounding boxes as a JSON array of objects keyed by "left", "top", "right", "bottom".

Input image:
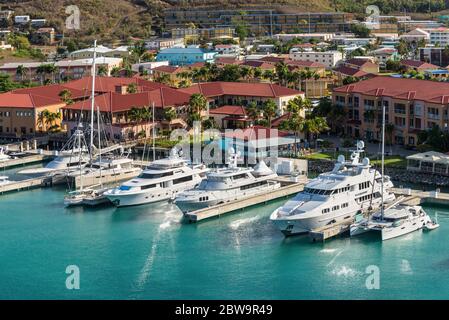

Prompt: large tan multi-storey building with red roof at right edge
[{"left": 332, "top": 77, "right": 449, "bottom": 145}]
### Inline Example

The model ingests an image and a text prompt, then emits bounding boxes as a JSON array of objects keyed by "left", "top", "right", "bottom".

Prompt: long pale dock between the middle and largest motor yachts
[{"left": 184, "top": 176, "right": 307, "bottom": 222}]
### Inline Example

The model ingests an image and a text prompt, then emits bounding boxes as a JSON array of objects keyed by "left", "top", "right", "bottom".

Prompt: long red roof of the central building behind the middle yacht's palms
[{"left": 178, "top": 81, "right": 303, "bottom": 98}]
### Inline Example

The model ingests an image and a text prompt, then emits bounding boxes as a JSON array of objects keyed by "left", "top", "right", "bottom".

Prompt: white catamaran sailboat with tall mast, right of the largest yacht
[{"left": 350, "top": 102, "right": 435, "bottom": 241}]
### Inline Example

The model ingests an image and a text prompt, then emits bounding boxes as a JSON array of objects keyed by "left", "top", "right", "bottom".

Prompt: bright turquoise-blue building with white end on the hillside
[{"left": 157, "top": 48, "right": 217, "bottom": 66}]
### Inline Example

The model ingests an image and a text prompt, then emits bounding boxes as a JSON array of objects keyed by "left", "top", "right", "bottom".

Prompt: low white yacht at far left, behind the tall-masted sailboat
[{"left": 18, "top": 124, "right": 90, "bottom": 177}]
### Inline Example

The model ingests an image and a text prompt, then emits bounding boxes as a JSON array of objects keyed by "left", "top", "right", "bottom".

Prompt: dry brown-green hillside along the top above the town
[{"left": 0, "top": 0, "right": 449, "bottom": 47}]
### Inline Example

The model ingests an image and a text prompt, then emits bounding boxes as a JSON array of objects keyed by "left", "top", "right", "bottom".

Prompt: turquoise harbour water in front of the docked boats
[{"left": 0, "top": 170, "right": 449, "bottom": 299}]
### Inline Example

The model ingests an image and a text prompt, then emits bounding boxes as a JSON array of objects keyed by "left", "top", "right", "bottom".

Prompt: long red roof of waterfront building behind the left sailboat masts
[{"left": 64, "top": 88, "right": 190, "bottom": 112}]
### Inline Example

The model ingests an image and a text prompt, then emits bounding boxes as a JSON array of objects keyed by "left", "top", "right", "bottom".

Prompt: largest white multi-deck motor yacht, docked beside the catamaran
[{"left": 270, "top": 141, "right": 395, "bottom": 236}]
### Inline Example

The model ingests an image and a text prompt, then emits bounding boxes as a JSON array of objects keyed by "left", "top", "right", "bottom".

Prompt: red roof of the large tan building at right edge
[{"left": 334, "top": 77, "right": 449, "bottom": 104}]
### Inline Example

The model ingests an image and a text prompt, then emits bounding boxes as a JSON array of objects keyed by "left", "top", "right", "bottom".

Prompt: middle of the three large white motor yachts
[{"left": 175, "top": 152, "right": 281, "bottom": 213}]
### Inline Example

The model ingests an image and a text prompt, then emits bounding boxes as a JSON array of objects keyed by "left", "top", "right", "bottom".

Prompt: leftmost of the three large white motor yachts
[{"left": 105, "top": 148, "right": 208, "bottom": 207}]
